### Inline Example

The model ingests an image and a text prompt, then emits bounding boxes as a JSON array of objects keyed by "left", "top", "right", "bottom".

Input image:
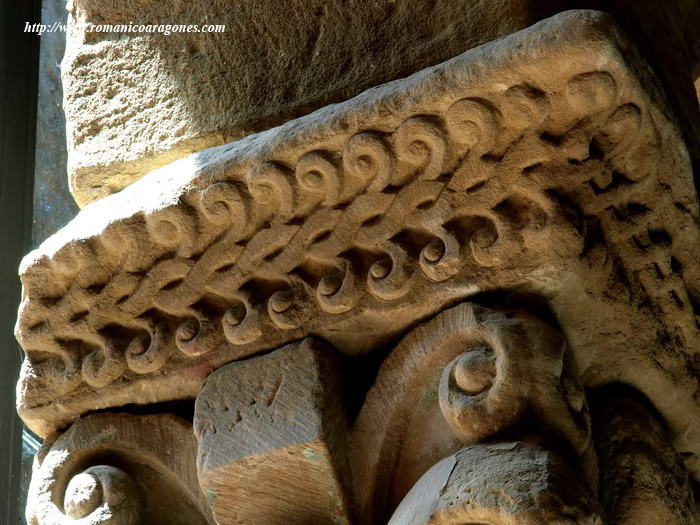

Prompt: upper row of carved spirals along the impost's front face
[{"left": 147, "top": 71, "right": 618, "bottom": 251}]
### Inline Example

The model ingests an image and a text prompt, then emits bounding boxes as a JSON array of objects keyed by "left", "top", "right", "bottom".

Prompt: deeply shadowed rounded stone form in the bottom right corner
[{"left": 592, "top": 385, "right": 695, "bottom": 525}]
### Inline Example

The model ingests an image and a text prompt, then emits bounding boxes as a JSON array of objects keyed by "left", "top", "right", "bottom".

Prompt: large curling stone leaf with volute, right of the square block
[{"left": 351, "top": 303, "right": 596, "bottom": 523}]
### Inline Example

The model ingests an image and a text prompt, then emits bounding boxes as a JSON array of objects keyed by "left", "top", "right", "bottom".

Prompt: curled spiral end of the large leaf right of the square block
[{"left": 439, "top": 310, "right": 591, "bottom": 454}]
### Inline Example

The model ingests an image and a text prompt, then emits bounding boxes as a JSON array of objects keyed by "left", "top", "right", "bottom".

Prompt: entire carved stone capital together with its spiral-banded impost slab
[{"left": 17, "top": 12, "right": 700, "bottom": 525}]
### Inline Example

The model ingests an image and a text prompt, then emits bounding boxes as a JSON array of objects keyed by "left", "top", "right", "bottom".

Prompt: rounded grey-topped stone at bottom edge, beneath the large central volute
[{"left": 389, "top": 443, "right": 600, "bottom": 525}]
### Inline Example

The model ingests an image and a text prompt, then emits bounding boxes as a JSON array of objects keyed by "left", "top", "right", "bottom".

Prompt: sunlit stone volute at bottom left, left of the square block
[{"left": 27, "top": 414, "right": 214, "bottom": 525}]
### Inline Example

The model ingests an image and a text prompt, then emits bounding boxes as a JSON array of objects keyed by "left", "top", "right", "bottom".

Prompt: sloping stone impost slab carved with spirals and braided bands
[{"left": 17, "top": 12, "right": 700, "bottom": 484}]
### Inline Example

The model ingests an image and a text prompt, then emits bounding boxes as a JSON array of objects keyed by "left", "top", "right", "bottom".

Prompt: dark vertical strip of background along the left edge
[{"left": 0, "top": 0, "right": 40, "bottom": 525}]
